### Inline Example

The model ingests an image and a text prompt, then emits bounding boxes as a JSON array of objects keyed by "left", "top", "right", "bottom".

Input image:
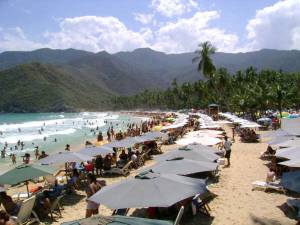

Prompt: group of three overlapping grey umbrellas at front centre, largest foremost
[{"left": 89, "top": 145, "right": 219, "bottom": 209}]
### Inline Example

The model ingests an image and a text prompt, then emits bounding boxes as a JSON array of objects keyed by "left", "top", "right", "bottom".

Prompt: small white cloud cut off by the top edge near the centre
[{"left": 151, "top": 0, "right": 198, "bottom": 17}]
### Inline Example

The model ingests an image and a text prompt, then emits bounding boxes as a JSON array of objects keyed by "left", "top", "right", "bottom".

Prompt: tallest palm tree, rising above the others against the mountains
[{"left": 193, "top": 41, "right": 217, "bottom": 79}]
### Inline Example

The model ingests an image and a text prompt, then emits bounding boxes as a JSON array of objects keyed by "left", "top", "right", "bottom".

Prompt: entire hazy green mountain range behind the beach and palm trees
[{"left": 0, "top": 48, "right": 300, "bottom": 111}]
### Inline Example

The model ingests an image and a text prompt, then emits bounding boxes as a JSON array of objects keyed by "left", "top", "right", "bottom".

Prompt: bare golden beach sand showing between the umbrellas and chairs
[{"left": 12, "top": 126, "right": 296, "bottom": 225}]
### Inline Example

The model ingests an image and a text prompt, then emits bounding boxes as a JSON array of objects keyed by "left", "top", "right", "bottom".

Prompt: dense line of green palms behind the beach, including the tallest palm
[{"left": 113, "top": 42, "right": 300, "bottom": 118}]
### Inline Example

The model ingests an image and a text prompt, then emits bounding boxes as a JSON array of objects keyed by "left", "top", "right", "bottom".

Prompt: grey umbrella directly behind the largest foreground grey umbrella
[{"left": 141, "top": 158, "right": 218, "bottom": 175}]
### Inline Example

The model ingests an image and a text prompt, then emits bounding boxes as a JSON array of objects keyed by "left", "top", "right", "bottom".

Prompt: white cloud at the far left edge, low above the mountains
[{"left": 0, "top": 27, "right": 43, "bottom": 52}]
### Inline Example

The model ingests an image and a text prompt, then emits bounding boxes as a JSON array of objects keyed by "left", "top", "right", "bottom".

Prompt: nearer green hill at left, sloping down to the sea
[{"left": 0, "top": 63, "right": 110, "bottom": 112}]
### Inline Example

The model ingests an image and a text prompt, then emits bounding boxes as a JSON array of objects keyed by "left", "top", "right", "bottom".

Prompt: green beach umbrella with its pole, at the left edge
[{"left": 0, "top": 164, "right": 56, "bottom": 196}]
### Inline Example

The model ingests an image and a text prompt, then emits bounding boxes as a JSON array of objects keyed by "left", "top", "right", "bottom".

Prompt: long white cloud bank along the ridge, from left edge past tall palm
[{"left": 0, "top": 11, "right": 238, "bottom": 53}]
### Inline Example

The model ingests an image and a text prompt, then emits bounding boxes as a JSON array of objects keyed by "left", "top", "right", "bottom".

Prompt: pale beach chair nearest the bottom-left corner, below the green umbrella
[{"left": 12, "top": 196, "right": 40, "bottom": 224}]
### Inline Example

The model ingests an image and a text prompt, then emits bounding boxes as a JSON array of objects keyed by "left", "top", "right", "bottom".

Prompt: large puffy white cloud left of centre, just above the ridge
[{"left": 45, "top": 16, "right": 147, "bottom": 52}]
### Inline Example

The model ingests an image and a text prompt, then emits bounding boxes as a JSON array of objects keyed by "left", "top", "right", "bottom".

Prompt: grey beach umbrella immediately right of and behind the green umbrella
[{"left": 37, "top": 152, "right": 93, "bottom": 164}]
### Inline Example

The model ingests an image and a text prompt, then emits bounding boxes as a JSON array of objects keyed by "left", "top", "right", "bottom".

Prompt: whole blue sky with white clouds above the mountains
[{"left": 0, "top": 0, "right": 300, "bottom": 53}]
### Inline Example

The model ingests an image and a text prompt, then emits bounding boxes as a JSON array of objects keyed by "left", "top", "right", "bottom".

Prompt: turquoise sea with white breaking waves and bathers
[{"left": 0, "top": 112, "right": 147, "bottom": 172}]
